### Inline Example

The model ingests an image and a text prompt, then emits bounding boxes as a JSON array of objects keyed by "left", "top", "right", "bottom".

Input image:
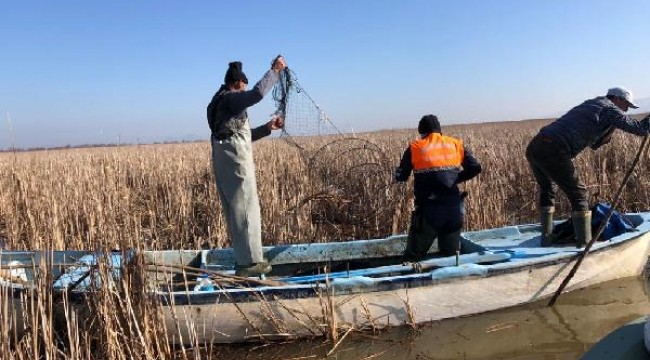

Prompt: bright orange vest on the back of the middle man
[{"left": 411, "top": 132, "right": 465, "bottom": 172}]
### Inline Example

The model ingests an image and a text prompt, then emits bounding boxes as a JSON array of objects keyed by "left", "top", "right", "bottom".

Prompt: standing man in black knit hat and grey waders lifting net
[{"left": 207, "top": 56, "right": 286, "bottom": 276}]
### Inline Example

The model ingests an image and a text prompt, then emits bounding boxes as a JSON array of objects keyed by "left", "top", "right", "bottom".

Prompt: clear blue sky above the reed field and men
[{"left": 0, "top": 0, "right": 650, "bottom": 148}]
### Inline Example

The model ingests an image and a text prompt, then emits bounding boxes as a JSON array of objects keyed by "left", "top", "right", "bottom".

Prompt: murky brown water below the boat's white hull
[{"left": 204, "top": 278, "right": 650, "bottom": 360}]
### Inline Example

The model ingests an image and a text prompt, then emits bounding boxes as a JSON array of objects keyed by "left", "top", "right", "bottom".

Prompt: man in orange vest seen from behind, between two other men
[{"left": 395, "top": 115, "right": 481, "bottom": 262}]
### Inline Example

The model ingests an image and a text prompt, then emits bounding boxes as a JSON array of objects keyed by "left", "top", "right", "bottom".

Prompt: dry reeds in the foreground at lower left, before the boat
[{"left": 0, "top": 253, "right": 362, "bottom": 359}]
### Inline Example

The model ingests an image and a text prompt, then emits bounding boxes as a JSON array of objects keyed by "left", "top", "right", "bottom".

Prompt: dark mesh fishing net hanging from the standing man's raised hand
[{"left": 273, "top": 69, "right": 404, "bottom": 232}]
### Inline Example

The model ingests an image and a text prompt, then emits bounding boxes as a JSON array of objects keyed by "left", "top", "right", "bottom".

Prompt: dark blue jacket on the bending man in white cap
[{"left": 539, "top": 96, "right": 650, "bottom": 158}]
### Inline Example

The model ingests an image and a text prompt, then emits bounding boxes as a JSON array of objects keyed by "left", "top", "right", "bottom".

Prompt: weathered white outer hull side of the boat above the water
[{"left": 163, "top": 225, "right": 650, "bottom": 344}]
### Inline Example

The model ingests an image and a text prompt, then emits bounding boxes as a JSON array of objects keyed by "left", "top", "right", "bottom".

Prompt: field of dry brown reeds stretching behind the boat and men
[{"left": 0, "top": 116, "right": 650, "bottom": 250}]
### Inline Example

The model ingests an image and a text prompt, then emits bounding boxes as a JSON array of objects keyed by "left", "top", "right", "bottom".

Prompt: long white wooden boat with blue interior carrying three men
[{"left": 2, "top": 213, "right": 650, "bottom": 344}]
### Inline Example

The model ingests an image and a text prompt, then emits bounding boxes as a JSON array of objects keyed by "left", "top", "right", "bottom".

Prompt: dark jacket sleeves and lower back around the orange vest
[{"left": 395, "top": 133, "right": 481, "bottom": 205}]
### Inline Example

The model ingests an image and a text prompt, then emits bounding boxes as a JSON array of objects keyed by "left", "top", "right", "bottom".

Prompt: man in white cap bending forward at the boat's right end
[{"left": 526, "top": 87, "right": 650, "bottom": 248}]
